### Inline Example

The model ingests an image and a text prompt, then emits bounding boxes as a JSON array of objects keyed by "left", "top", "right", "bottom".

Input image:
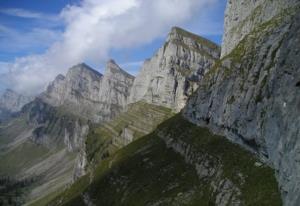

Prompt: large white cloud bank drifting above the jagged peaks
[{"left": 1, "top": 0, "right": 218, "bottom": 94}]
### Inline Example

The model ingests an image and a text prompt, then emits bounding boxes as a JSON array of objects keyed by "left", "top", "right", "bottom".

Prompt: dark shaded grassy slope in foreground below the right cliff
[{"left": 44, "top": 115, "right": 281, "bottom": 206}]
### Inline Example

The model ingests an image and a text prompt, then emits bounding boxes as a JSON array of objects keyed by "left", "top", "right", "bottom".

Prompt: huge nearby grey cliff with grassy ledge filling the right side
[{"left": 184, "top": 0, "right": 300, "bottom": 206}]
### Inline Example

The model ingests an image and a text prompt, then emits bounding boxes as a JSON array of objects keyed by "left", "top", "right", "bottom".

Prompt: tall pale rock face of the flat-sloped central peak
[{"left": 129, "top": 27, "right": 220, "bottom": 111}]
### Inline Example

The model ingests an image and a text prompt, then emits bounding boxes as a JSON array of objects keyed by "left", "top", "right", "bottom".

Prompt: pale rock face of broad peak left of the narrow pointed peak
[{"left": 40, "top": 64, "right": 103, "bottom": 121}]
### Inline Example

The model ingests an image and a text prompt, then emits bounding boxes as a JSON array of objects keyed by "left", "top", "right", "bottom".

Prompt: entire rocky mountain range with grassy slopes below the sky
[{"left": 0, "top": 0, "right": 300, "bottom": 206}]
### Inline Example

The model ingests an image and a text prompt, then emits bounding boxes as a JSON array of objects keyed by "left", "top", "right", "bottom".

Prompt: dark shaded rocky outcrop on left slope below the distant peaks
[{"left": 22, "top": 99, "right": 89, "bottom": 152}]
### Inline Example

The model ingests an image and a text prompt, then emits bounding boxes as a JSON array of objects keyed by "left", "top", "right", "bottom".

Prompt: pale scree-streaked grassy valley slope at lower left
[{"left": 0, "top": 104, "right": 86, "bottom": 205}]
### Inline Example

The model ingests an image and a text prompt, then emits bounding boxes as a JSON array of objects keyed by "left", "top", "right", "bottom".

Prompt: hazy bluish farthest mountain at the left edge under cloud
[{"left": 0, "top": 89, "right": 33, "bottom": 121}]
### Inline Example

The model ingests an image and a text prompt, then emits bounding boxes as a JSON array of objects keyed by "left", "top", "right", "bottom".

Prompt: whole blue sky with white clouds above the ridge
[{"left": 0, "top": 0, "right": 226, "bottom": 95}]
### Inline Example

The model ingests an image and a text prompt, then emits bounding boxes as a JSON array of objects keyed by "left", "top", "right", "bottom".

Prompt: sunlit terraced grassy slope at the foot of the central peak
[{"left": 86, "top": 102, "right": 173, "bottom": 169}]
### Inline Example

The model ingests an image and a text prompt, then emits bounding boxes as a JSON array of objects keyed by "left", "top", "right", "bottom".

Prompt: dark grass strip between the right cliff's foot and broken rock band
[{"left": 159, "top": 115, "right": 282, "bottom": 206}]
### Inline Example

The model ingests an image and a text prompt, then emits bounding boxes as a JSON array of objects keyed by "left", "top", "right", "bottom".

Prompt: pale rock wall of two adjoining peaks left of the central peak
[{"left": 39, "top": 60, "right": 134, "bottom": 122}]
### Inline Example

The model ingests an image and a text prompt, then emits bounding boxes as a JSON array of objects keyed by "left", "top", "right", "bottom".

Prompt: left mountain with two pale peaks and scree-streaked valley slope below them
[{"left": 0, "top": 61, "right": 134, "bottom": 205}]
